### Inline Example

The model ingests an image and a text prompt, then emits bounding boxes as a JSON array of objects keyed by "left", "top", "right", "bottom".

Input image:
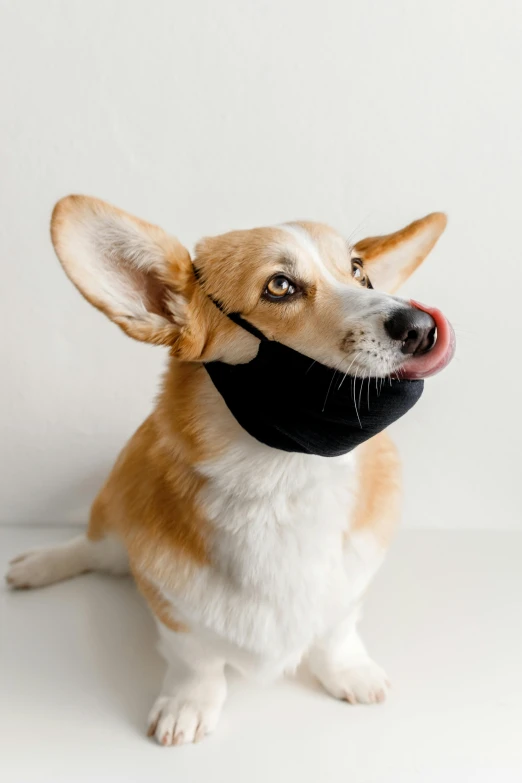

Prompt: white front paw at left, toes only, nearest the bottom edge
[{"left": 147, "top": 681, "right": 226, "bottom": 745}]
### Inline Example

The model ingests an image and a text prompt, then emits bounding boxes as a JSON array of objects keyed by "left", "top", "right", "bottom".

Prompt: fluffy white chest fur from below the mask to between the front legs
[{"left": 158, "top": 433, "right": 382, "bottom": 673}]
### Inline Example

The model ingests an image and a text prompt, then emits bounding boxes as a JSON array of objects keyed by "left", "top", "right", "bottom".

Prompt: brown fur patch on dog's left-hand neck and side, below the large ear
[{"left": 89, "top": 361, "right": 216, "bottom": 596}]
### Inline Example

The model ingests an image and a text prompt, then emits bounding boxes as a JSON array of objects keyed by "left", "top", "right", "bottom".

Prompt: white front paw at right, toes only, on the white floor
[{"left": 314, "top": 658, "right": 390, "bottom": 704}]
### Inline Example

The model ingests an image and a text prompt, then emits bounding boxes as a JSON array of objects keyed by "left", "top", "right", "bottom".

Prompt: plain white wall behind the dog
[{"left": 0, "top": 0, "right": 522, "bottom": 528}]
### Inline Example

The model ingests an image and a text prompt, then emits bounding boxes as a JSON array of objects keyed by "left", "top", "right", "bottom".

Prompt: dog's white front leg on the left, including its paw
[{"left": 148, "top": 621, "right": 227, "bottom": 745}]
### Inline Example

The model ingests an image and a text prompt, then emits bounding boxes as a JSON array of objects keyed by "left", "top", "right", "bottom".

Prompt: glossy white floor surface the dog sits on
[{"left": 0, "top": 527, "right": 522, "bottom": 783}]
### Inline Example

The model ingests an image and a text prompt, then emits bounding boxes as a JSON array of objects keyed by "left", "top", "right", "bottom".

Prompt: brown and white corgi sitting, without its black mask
[{"left": 7, "top": 196, "right": 451, "bottom": 745}]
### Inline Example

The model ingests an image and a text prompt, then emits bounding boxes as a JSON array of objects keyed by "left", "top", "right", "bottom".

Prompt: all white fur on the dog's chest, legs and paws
[{"left": 4, "top": 428, "right": 387, "bottom": 728}]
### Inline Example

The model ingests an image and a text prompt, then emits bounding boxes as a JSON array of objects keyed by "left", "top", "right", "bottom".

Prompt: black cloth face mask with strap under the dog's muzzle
[{"left": 195, "top": 270, "right": 424, "bottom": 457}]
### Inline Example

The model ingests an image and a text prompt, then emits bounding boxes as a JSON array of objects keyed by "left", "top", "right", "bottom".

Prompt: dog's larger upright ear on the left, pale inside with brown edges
[{"left": 51, "top": 196, "right": 193, "bottom": 345}]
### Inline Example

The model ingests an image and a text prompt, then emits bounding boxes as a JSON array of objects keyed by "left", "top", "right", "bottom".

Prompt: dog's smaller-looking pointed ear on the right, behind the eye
[{"left": 352, "top": 212, "right": 447, "bottom": 293}]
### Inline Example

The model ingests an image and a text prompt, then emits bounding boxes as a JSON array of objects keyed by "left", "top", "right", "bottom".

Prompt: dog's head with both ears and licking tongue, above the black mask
[{"left": 51, "top": 196, "right": 452, "bottom": 377}]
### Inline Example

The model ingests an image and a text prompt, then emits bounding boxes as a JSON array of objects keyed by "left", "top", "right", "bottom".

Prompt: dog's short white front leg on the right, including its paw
[{"left": 308, "top": 610, "right": 390, "bottom": 704}]
